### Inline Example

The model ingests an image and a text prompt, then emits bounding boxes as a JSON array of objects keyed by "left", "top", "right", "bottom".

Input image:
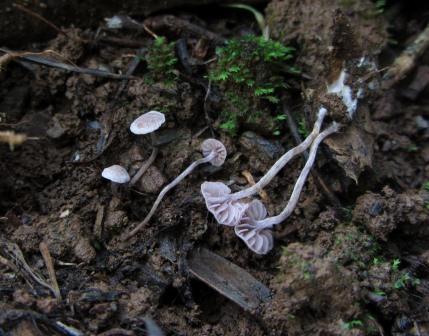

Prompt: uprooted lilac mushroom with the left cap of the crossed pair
[{"left": 201, "top": 107, "right": 327, "bottom": 226}]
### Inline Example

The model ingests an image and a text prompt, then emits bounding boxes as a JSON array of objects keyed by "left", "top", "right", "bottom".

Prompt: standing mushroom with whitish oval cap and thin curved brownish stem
[{"left": 130, "top": 111, "right": 165, "bottom": 186}]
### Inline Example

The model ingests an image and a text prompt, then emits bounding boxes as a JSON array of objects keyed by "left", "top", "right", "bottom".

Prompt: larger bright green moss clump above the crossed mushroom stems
[{"left": 209, "top": 35, "right": 296, "bottom": 135}]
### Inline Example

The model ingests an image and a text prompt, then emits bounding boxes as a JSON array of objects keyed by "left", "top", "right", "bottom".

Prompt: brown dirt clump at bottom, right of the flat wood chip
[{"left": 264, "top": 243, "right": 360, "bottom": 335}]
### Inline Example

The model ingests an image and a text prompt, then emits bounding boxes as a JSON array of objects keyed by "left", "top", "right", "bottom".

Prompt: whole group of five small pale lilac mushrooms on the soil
[{"left": 102, "top": 107, "right": 339, "bottom": 254}]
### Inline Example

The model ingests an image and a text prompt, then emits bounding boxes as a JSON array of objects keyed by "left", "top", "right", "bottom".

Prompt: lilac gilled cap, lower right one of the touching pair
[{"left": 234, "top": 200, "right": 274, "bottom": 254}]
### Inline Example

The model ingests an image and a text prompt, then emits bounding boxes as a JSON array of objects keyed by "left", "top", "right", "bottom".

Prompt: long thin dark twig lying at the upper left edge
[{"left": 0, "top": 48, "right": 133, "bottom": 79}]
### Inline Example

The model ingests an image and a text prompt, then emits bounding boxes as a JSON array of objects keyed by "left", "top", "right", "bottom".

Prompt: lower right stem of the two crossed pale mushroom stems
[{"left": 256, "top": 122, "right": 340, "bottom": 230}]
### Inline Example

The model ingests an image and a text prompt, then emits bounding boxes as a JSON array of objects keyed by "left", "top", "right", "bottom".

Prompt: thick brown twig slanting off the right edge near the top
[{"left": 382, "top": 24, "right": 429, "bottom": 89}]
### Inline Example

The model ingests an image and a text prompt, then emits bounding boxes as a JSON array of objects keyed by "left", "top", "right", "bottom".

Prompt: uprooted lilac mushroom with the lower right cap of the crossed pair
[{"left": 234, "top": 123, "right": 339, "bottom": 254}]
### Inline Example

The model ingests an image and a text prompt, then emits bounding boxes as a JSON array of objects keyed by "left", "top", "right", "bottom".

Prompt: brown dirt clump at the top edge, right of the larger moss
[{"left": 266, "top": 0, "right": 388, "bottom": 81}]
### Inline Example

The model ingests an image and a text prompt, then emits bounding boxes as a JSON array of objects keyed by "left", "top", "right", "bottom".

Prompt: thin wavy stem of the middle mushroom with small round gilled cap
[{"left": 124, "top": 151, "right": 217, "bottom": 239}]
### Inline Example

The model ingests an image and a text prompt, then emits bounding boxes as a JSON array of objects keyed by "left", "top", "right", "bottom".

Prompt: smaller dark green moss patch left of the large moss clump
[{"left": 144, "top": 37, "right": 177, "bottom": 86}]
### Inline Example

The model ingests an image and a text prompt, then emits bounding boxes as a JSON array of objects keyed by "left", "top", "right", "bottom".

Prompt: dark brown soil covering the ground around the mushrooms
[{"left": 0, "top": 0, "right": 429, "bottom": 336}]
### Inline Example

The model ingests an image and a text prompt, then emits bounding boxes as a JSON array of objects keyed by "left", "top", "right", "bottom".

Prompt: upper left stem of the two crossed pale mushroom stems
[{"left": 228, "top": 107, "right": 327, "bottom": 200}]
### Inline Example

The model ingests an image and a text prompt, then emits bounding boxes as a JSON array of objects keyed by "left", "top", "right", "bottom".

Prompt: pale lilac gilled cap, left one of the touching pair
[{"left": 201, "top": 182, "right": 247, "bottom": 226}]
